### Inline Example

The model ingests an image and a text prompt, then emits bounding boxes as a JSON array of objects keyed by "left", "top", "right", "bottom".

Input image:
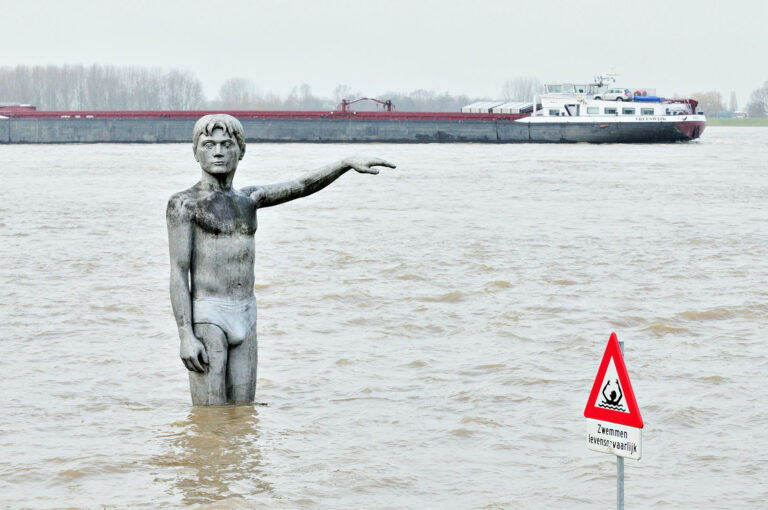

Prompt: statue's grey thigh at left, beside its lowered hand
[{"left": 189, "top": 324, "right": 228, "bottom": 405}]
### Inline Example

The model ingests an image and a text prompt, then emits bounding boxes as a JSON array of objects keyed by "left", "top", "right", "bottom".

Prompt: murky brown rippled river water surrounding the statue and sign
[{"left": 0, "top": 128, "right": 768, "bottom": 508}]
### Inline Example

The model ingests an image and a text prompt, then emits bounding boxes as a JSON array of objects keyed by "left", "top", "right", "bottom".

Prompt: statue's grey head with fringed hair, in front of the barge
[{"left": 192, "top": 114, "right": 245, "bottom": 175}]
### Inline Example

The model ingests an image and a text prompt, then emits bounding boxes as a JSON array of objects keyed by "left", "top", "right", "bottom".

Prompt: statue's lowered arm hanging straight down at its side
[{"left": 165, "top": 195, "right": 208, "bottom": 372}]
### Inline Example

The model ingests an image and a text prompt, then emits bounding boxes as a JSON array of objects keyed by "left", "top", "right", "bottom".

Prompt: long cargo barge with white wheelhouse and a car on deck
[{"left": 0, "top": 90, "right": 706, "bottom": 144}]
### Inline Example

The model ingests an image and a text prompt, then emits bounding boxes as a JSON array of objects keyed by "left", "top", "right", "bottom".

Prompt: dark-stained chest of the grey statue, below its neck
[{"left": 195, "top": 193, "right": 256, "bottom": 235}]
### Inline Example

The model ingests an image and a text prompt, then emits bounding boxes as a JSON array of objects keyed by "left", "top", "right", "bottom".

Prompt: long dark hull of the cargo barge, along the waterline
[{"left": 0, "top": 116, "right": 706, "bottom": 143}]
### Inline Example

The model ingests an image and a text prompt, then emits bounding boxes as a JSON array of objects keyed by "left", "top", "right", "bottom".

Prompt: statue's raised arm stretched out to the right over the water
[{"left": 242, "top": 158, "right": 395, "bottom": 207}]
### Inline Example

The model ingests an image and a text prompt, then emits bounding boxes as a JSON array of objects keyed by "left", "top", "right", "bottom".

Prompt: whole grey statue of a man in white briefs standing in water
[{"left": 166, "top": 115, "right": 395, "bottom": 405}]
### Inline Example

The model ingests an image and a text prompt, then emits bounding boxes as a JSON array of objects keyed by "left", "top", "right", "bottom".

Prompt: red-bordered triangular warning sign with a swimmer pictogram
[{"left": 584, "top": 333, "right": 643, "bottom": 428}]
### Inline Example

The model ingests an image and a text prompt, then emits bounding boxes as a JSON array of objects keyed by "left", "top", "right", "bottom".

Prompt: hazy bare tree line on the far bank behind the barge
[{"left": 0, "top": 65, "right": 768, "bottom": 117}]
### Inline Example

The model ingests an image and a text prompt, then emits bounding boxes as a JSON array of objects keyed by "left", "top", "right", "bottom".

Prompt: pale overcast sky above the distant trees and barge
[{"left": 0, "top": 0, "right": 768, "bottom": 107}]
